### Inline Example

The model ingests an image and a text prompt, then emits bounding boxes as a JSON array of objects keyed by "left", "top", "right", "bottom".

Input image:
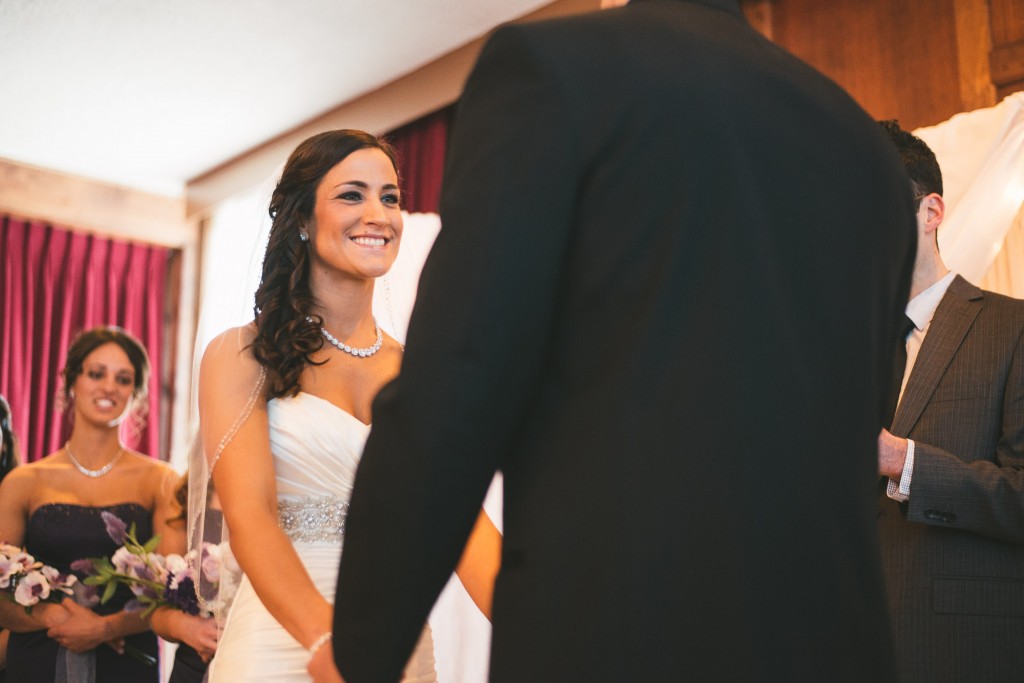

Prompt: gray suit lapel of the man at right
[{"left": 892, "top": 275, "right": 984, "bottom": 436}]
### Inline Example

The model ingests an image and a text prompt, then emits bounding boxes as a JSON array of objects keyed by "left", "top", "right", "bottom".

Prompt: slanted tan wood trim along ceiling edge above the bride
[{"left": 185, "top": 0, "right": 601, "bottom": 219}]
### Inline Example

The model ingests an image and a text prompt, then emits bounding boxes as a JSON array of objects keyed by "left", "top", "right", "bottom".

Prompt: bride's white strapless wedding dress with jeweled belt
[{"left": 209, "top": 392, "right": 437, "bottom": 683}]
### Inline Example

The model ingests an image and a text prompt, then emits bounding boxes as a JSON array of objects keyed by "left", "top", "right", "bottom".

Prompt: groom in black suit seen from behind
[{"left": 325, "top": 0, "right": 915, "bottom": 683}]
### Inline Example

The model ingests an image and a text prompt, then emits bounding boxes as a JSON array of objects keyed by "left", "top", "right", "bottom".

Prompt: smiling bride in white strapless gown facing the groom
[{"left": 189, "top": 130, "right": 497, "bottom": 683}]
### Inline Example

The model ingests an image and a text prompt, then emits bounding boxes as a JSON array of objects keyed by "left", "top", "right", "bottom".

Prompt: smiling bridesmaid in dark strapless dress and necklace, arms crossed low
[{"left": 0, "top": 327, "right": 177, "bottom": 683}]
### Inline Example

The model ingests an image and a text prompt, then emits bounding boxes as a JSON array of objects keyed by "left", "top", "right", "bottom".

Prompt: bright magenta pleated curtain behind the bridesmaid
[{"left": 0, "top": 216, "right": 175, "bottom": 462}]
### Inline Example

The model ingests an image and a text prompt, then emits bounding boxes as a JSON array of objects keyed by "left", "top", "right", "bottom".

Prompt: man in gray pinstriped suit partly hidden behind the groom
[{"left": 879, "top": 121, "right": 1024, "bottom": 683}]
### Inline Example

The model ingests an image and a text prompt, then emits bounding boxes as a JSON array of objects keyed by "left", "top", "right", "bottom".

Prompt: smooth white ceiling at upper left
[{"left": 0, "top": 0, "right": 550, "bottom": 197}]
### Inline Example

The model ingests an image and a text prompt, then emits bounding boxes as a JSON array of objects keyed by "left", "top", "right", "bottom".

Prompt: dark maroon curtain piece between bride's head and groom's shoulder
[{"left": 385, "top": 105, "right": 455, "bottom": 213}]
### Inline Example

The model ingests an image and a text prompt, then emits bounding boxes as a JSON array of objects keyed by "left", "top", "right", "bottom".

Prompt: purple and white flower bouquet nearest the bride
[{"left": 72, "top": 512, "right": 232, "bottom": 616}]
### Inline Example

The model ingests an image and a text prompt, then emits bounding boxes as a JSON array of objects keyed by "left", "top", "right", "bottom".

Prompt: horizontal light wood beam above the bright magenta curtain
[{"left": 0, "top": 159, "right": 197, "bottom": 248}]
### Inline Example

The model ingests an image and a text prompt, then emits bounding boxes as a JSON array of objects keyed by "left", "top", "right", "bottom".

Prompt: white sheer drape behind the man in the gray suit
[{"left": 914, "top": 92, "right": 1024, "bottom": 298}]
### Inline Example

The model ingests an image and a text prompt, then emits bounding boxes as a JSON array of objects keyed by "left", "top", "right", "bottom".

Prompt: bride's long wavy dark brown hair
[{"left": 252, "top": 130, "right": 398, "bottom": 398}]
